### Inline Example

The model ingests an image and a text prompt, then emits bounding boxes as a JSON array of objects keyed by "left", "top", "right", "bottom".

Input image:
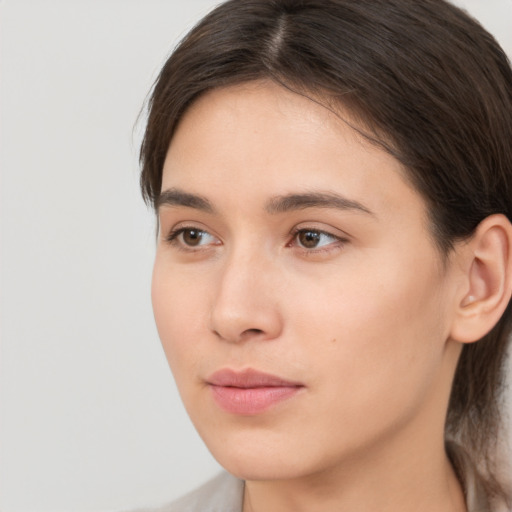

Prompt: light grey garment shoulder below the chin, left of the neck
[{"left": 133, "top": 472, "right": 244, "bottom": 512}]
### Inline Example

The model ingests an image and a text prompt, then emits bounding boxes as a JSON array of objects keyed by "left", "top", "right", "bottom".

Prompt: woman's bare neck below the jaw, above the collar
[{"left": 243, "top": 420, "right": 466, "bottom": 512}]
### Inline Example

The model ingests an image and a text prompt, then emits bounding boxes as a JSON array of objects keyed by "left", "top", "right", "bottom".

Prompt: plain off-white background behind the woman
[{"left": 0, "top": 0, "right": 512, "bottom": 512}]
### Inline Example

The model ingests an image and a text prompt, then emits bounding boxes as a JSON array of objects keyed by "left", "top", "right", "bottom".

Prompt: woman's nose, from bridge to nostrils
[{"left": 211, "top": 248, "right": 283, "bottom": 343}]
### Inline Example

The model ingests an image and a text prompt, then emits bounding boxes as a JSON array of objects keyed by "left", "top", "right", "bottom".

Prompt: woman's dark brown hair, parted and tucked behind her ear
[{"left": 140, "top": 0, "right": 512, "bottom": 504}]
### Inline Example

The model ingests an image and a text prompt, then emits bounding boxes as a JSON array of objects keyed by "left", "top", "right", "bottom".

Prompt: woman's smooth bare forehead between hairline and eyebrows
[{"left": 162, "top": 81, "right": 425, "bottom": 222}]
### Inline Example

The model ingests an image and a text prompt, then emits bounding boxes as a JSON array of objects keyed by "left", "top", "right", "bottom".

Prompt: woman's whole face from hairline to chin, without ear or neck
[{"left": 152, "top": 82, "right": 460, "bottom": 479}]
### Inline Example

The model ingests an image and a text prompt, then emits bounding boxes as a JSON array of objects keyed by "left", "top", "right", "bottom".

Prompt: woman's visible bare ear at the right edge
[{"left": 451, "top": 214, "right": 512, "bottom": 343}]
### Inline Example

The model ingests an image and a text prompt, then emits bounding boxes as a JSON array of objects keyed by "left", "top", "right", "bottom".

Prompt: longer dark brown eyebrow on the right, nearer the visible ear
[{"left": 265, "top": 192, "right": 374, "bottom": 215}]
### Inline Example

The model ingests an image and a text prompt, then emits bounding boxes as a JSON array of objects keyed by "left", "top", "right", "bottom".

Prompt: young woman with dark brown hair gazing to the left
[{"left": 141, "top": 0, "right": 512, "bottom": 512}]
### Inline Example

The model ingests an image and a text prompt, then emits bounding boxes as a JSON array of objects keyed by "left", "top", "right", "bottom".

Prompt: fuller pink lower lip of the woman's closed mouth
[{"left": 210, "top": 385, "right": 301, "bottom": 416}]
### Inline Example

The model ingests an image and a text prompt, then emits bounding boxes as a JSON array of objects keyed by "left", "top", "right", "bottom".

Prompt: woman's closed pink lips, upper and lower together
[{"left": 207, "top": 368, "right": 304, "bottom": 416}]
